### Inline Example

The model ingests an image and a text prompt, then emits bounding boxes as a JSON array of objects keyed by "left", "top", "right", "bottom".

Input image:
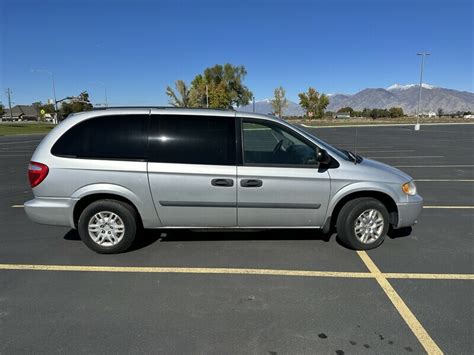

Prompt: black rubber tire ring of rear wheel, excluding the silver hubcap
[{"left": 77, "top": 200, "right": 138, "bottom": 254}]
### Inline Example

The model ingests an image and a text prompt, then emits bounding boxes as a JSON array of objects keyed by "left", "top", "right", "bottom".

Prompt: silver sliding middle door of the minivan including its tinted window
[{"left": 148, "top": 110, "right": 237, "bottom": 227}]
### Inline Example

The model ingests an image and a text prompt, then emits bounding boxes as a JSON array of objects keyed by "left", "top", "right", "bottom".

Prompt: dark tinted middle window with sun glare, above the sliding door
[{"left": 148, "top": 115, "right": 236, "bottom": 165}]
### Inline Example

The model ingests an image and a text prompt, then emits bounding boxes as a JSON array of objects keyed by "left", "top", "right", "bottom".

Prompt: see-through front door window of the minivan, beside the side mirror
[{"left": 242, "top": 120, "right": 316, "bottom": 166}]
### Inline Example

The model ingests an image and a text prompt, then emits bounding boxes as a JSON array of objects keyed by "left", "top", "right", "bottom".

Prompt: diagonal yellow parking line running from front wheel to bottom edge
[{"left": 357, "top": 251, "right": 443, "bottom": 354}]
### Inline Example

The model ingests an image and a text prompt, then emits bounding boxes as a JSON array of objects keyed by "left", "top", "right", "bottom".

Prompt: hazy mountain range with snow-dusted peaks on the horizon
[{"left": 238, "top": 84, "right": 474, "bottom": 116}]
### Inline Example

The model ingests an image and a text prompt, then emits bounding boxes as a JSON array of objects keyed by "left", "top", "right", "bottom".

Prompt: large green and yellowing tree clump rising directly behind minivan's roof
[{"left": 166, "top": 63, "right": 253, "bottom": 109}]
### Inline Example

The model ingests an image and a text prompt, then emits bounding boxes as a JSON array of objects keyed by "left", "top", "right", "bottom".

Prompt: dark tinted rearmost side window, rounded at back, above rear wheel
[{"left": 51, "top": 115, "right": 148, "bottom": 160}]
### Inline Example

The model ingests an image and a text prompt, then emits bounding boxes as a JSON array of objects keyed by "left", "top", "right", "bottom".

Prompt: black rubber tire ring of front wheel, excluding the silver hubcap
[{"left": 336, "top": 197, "right": 389, "bottom": 250}]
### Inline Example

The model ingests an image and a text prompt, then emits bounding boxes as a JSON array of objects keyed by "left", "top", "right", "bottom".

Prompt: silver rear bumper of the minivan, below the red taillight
[{"left": 24, "top": 197, "right": 76, "bottom": 228}]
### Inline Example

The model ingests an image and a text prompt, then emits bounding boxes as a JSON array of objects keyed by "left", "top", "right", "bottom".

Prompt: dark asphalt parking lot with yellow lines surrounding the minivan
[{"left": 0, "top": 125, "right": 474, "bottom": 355}]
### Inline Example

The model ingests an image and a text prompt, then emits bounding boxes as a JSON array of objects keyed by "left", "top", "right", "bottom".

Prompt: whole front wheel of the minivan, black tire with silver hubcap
[{"left": 336, "top": 197, "right": 389, "bottom": 250}]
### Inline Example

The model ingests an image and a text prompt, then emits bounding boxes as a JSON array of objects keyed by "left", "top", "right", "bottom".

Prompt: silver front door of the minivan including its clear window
[{"left": 237, "top": 118, "right": 330, "bottom": 227}]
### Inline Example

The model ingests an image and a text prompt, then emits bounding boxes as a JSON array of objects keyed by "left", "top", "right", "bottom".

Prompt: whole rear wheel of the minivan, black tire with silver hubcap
[{"left": 77, "top": 200, "right": 138, "bottom": 254}]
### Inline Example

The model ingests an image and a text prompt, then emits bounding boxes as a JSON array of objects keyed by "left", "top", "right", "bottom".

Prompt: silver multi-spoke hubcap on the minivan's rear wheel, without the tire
[{"left": 88, "top": 211, "right": 125, "bottom": 247}]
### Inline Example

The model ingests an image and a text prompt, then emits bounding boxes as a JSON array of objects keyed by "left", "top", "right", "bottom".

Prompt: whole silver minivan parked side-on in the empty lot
[{"left": 25, "top": 107, "right": 423, "bottom": 253}]
